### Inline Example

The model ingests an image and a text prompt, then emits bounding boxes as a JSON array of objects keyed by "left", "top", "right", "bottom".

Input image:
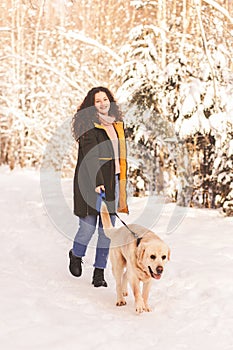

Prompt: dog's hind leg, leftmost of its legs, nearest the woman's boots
[{"left": 111, "top": 249, "right": 126, "bottom": 306}]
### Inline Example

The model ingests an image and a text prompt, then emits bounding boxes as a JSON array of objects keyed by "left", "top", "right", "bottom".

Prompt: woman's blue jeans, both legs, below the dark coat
[{"left": 73, "top": 176, "right": 119, "bottom": 269}]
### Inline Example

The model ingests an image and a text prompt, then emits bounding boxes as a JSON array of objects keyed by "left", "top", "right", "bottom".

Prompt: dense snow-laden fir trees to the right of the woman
[{"left": 118, "top": 2, "right": 233, "bottom": 215}]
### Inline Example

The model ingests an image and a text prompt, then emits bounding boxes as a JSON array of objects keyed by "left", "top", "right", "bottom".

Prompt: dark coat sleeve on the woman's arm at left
[{"left": 79, "top": 129, "right": 104, "bottom": 188}]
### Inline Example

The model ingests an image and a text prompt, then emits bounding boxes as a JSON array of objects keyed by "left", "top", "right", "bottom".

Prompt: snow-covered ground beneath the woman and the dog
[{"left": 0, "top": 167, "right": 233, "bottom": 350}]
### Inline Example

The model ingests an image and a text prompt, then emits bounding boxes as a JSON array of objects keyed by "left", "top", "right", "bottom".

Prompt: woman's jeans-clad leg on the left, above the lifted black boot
[{"left": 72, "top": 215, "right": 97, "bottom": 257}]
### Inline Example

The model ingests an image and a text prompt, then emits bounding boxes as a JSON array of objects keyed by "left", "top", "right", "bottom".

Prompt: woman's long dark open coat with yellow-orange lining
[{"left": 73, "top": 122, "right": 128, "bottom": 217}]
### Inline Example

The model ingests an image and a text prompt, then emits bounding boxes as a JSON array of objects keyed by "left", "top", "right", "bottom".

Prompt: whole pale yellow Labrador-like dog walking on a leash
[{"left": 100, "top": 202, "right": 170, "bottom": 313}]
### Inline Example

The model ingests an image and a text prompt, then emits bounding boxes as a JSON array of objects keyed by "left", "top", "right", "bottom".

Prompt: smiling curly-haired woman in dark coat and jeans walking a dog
[{"left": 69, "top": 87, "right": 128, "bottom": 287}]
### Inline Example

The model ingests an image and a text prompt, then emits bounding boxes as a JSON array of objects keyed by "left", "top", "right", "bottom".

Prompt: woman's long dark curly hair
[{"left": 72, "top": 86, "right": 122, "bottom": 141}]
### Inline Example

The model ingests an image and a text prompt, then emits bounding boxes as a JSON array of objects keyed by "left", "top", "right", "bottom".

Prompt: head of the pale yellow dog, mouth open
[{"left": 136, "top": 239, "right": 170, "bottom": 279}]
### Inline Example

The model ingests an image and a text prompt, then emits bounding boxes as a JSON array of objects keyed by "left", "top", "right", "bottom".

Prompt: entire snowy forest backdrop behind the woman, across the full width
[{"left": 0, "top": 0, "right": 233, "bottom": 216}]
